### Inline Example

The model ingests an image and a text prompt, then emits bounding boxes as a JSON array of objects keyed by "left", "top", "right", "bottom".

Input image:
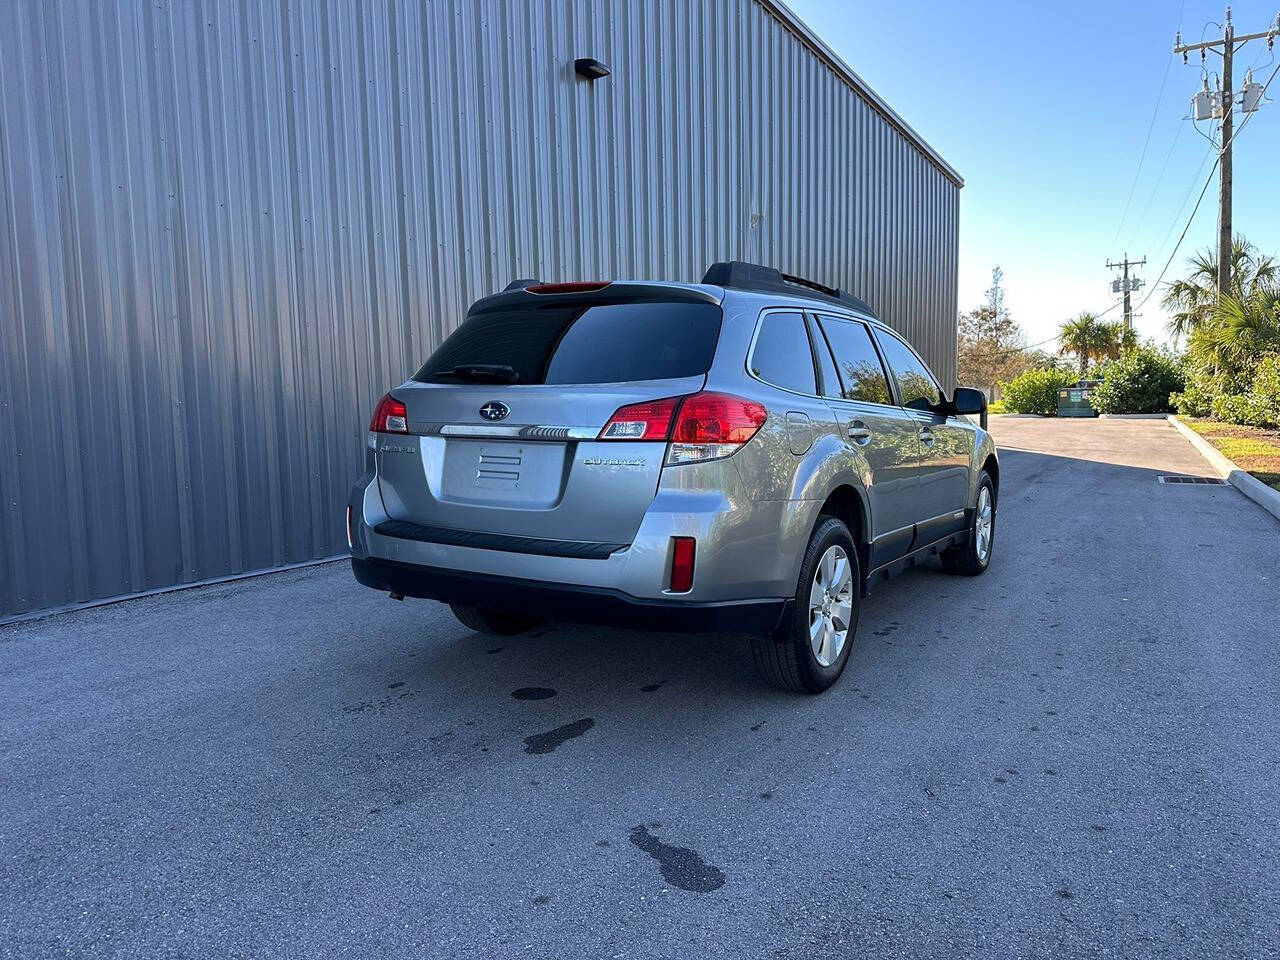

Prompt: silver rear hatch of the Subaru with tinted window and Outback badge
[{"left": 378, "top": 284, "right": 721, "bottom": 547}]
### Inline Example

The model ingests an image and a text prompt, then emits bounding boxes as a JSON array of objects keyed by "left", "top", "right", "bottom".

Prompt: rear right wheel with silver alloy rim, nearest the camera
[{"left": 751, "top": 516, "right": 863, "bottom": 694}]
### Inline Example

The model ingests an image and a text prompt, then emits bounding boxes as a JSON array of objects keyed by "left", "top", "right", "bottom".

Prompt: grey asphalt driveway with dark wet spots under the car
[{"left": 0, "top": 419, "right": 1280, "bottom": 957}]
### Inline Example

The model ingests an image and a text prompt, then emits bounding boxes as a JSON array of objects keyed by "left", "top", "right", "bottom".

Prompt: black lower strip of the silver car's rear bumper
[{"left": 351, "top": 557, "right": 794, "bottom": 634}]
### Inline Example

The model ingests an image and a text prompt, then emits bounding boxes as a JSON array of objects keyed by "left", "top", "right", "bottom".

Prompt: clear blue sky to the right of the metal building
[{"left": 788, "top": 0, "right": 1280, "bottom": 348}]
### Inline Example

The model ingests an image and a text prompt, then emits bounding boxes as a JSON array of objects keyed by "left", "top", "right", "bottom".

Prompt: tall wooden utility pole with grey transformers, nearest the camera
[{"left": 1172, "top": 6, "right": 1280, "bottom": 296}]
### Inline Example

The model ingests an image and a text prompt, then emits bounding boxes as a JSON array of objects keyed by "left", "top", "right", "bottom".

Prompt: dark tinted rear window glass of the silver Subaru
[{"left": 413, "top": 302, "right": 721, "bottom": 384}]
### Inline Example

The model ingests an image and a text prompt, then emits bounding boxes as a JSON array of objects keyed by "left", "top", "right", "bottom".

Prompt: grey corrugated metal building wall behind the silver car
[{"left": 0, "top": 0, "right": 959, "bottom": 617}]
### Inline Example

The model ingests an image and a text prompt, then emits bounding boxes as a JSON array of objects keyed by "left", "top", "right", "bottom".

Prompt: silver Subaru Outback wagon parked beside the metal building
[{"left": 347, "top": 262, "right": 1000, "bottom": 692}]
